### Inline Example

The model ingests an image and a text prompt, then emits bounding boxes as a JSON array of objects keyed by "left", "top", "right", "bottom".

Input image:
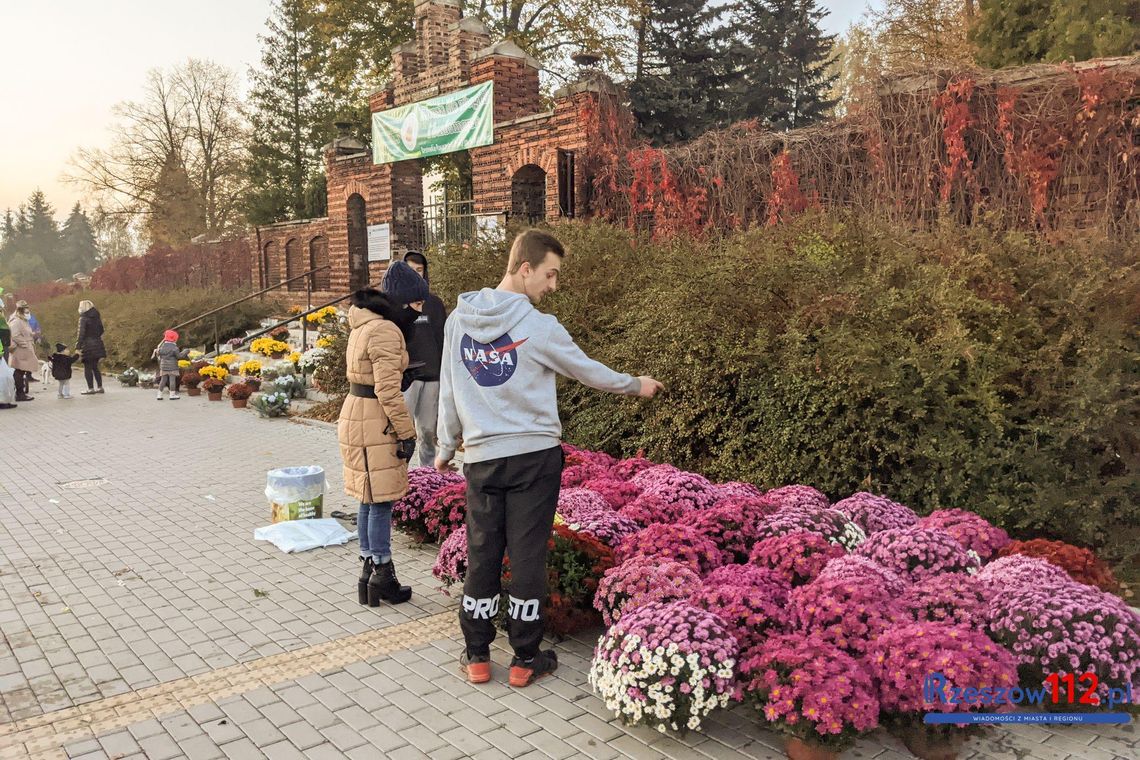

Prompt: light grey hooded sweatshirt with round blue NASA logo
[{"left": 437, "top": 287, "right": 641, "bottom": 463}]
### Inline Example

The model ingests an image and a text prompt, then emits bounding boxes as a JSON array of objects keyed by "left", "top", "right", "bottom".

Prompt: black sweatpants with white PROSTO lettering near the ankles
[{"left": 459, "top": 446, "right": 564, "bottom": 660}]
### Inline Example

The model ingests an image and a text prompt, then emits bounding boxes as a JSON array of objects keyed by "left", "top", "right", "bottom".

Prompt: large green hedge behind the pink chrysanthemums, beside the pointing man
[{"left": 432, "top": 215, "right": 1140, "bottom": 555}]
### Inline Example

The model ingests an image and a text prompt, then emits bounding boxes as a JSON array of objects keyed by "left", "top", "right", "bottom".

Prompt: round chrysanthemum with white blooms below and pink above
[{"left": 588, "top": 599, "right": 738, "bottom": 734}]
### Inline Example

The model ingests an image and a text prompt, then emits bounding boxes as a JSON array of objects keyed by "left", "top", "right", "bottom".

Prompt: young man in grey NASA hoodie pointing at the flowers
[{"left": 435, "top": 230, "right": 663, "bottom": 686}]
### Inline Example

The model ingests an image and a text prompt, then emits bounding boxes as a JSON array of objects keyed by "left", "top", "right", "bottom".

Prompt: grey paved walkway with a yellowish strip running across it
[{"left": 0, "top": 383, "right": 1140, "bottom": 760}]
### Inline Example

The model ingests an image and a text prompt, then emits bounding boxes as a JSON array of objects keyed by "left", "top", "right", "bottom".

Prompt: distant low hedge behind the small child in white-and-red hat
[{"left": 31, "top": 288, "right": 276, "bottom": 369}]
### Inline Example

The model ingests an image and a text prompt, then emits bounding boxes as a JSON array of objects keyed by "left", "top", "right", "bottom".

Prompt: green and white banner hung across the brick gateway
[{"left": 372, "top": 82, "right": 495, "bottom": 164}]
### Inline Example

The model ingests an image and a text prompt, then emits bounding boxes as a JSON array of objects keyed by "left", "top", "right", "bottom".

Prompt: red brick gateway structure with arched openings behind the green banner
[{"left": 253, "top": 0, "right": 595, "bottom": 303}]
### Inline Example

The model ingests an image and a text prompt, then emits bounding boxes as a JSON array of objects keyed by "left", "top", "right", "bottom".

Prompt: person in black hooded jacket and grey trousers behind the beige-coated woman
[{"left": 404, "top": 251, "right": 447, "bottom": 467}]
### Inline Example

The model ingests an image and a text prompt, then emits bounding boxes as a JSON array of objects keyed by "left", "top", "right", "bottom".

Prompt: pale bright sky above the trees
[{"left": 0, "top": 0, "right": 881, "bottom": 218}]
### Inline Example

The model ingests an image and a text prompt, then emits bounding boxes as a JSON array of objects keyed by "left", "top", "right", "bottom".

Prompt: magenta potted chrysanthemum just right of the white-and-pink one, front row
[{"left": 740, "top": 634, "right": 879, "bottom": 760}]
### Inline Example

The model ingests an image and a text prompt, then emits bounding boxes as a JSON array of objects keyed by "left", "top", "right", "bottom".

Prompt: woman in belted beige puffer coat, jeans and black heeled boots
[{"left": 336, "top": 273, "right": 428, "bottom": 607}]
